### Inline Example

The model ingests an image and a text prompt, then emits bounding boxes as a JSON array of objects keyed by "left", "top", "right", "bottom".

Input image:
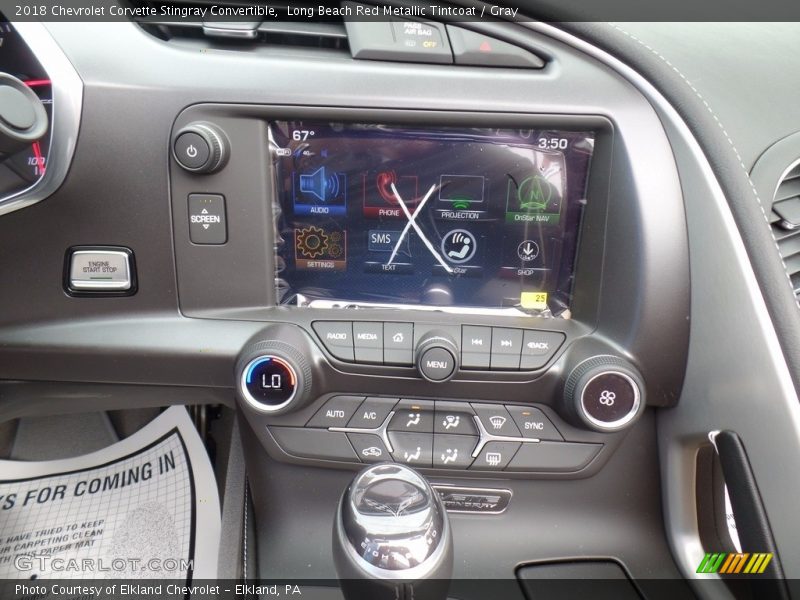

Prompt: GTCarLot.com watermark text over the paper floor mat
[{"left": 14, "top": 555, "right": 194, "bottom": 573}]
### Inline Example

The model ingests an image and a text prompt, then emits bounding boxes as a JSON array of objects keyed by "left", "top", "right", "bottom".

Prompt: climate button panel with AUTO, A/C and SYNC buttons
[{"left": 268, "top": 395, "right": 603, "bottom": 473}]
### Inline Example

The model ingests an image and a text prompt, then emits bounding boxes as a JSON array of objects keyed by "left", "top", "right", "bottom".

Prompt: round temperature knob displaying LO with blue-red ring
[{"left": 236, "top": 340, "right": 311, "bottom": 414}]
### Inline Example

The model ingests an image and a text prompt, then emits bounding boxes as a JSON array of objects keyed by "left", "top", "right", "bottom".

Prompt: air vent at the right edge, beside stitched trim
[{"left": 770, "top": 165, "right": 800, "bottom": 296}]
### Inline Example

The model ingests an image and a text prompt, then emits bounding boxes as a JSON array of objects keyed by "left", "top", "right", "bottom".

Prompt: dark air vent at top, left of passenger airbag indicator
[{"left": 127, "top": 0, "right": 347, "bottom": 50}]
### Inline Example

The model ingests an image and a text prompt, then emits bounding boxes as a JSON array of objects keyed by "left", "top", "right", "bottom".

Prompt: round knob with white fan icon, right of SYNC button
[{"left": 564, "top": 356, "right": 645, "bottom": 432}]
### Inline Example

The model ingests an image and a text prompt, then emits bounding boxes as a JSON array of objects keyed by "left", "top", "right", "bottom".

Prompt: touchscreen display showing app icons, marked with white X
[{"left": 269, "top": 121, "right": 594, "bottom": 316}]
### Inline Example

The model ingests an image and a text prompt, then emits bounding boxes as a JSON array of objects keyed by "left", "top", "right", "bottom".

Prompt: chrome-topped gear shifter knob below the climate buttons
[{"left": 333, "top": 463, "right": 453, "bottom": 600}]
